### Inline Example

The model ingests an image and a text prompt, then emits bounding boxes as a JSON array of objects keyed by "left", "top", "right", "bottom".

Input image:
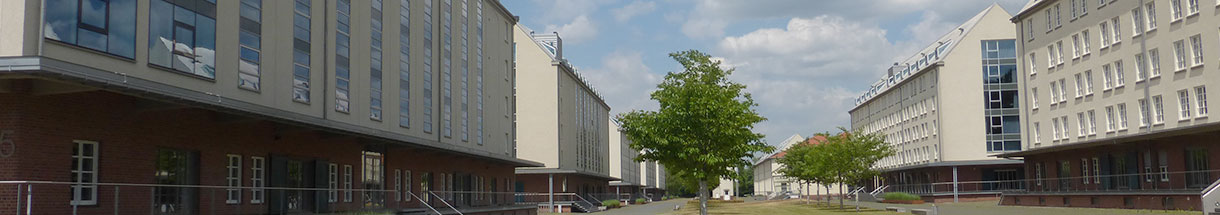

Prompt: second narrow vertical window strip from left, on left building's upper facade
[{"left": 293, "top": 0, "right": 312, "bottom": 104}]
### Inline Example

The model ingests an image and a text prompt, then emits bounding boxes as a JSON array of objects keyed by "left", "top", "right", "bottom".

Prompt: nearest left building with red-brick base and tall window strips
[{"left": 0, "top": 0, "right": 543, "bottom": 214}]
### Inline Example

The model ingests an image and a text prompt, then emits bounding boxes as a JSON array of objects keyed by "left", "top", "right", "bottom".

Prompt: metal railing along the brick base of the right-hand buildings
[{"left": 875, "top": 169, "right": 1220, "bottom": 195}]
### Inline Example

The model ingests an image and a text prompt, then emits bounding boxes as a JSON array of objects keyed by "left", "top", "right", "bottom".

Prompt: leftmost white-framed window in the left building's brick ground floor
[{"left": 71, "top": 140, "right": 98, "bottom": 205}]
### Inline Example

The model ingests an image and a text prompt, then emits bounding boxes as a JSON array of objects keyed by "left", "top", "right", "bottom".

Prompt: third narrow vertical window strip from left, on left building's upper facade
[{"left": 334, "top": 0, "right": 351, "bottom": 114}]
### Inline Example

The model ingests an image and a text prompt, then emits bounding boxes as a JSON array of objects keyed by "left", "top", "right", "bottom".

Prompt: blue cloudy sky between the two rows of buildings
[{"left": 501, "top": 0, "right": 1027, "bottom": 154}]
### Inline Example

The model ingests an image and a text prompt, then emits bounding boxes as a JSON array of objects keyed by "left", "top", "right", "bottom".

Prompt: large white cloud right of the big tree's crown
[{"left": 716, "top": 16, "right": 899, "bottom": 144}]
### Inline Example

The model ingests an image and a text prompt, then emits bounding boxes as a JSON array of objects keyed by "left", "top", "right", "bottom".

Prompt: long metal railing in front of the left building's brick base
[{"left": 0, "top": 181, "right": 461, "bottom": 215}]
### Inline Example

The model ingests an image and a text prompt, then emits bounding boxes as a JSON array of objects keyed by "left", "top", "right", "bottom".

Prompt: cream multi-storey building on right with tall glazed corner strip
[{"left": 850, "top": 5, "right": 1024, "bottom": 200}]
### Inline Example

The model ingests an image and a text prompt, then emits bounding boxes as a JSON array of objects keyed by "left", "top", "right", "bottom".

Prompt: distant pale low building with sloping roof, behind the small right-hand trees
[{"left": 754, "top": 134, "right": 842, "bottom": 199}]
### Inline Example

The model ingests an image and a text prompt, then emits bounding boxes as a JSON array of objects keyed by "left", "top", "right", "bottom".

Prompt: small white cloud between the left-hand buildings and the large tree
[{"left": 581, "top": 50, "right": 662, "bottom": 115}]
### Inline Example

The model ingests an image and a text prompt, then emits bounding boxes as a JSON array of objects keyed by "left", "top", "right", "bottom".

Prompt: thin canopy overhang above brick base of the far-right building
[{"left": 992, "top": 122, "right": 1220, "bottom": 158}]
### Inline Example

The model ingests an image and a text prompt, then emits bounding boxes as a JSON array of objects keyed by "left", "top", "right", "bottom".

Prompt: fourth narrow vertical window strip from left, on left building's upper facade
[{"left": 368, "top": 0, "right": 384, "bottom": 120}]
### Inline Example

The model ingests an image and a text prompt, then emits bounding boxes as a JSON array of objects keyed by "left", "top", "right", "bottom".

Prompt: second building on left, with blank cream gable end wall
[{"left": 512, "top": 26, "right": 619, "bottom": 202}]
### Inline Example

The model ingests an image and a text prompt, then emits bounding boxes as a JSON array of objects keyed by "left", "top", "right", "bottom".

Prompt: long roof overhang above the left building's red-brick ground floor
[{"left": 0, "top": 56, "right": 543, "bottom": 167}]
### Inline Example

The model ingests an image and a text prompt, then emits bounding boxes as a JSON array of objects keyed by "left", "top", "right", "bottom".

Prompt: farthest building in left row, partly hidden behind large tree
[{"left": 609, "top": 121, "right": 644, "bottom": 203}]
